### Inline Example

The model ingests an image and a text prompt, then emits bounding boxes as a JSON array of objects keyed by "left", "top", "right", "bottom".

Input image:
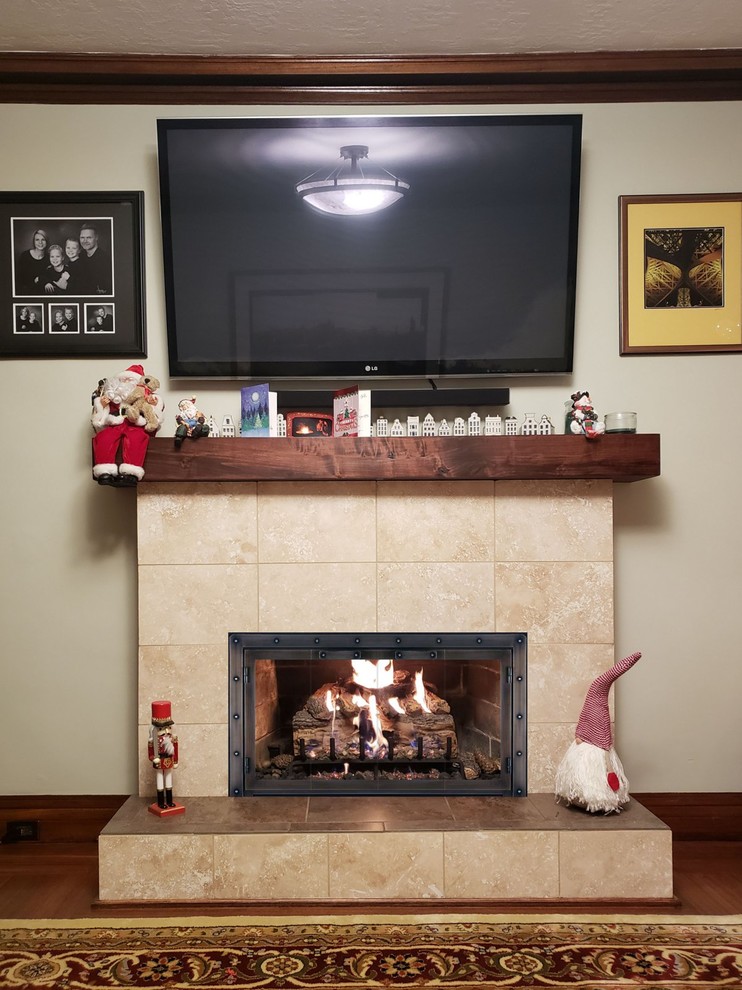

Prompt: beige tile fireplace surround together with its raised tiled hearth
[{"left": 99, "top": 481, "right": 672, "bottom": 903}]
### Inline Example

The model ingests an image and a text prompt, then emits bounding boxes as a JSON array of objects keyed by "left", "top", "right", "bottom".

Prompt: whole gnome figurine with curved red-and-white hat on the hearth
[{"left": 555, "top": 653, "right": 641, "bottom": 815}]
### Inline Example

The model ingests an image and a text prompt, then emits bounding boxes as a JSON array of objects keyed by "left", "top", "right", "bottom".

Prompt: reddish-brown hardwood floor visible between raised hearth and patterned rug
[{"left": 0, "top": 840, "right": 742, "bottom": 918}]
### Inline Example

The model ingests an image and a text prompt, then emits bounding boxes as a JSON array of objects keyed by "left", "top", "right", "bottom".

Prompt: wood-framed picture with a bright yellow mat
[{"left": 619, "top": 193, "right": 742, "bottom": 354}]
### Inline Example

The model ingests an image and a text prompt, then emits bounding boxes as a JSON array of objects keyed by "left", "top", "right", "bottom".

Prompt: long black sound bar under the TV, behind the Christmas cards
[{"left": 276, "top": 387, "right": 510, "bottom": 412}]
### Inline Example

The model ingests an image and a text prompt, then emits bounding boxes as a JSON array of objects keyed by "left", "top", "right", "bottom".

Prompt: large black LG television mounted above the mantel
[{"left": 157, "top": 113, "right": 582, "bottom": 380}]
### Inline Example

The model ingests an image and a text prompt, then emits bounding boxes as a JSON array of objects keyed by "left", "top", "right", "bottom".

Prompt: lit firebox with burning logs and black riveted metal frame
[{"left": 229, "top": 633, "right": 527, "bottom": 797}]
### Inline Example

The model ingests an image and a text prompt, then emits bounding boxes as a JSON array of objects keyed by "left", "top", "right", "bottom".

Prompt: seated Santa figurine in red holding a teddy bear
[{"left": 91, "top": 364, "right": 165, "bottom": 487}]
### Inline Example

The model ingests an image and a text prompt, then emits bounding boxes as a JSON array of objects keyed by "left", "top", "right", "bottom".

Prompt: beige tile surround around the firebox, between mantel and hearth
[{"left": 137, "top": 481, "right": 614, "bottom": 797}]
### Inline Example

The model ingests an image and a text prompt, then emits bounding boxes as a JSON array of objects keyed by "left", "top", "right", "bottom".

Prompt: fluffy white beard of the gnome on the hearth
[{"left": 555, "top": 740, "right": 629, "bottom": 814}]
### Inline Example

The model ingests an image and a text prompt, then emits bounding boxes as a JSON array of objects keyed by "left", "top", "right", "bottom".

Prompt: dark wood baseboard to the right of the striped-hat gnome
[{"left": 632, "top": 791, "right": 742, "bottom": 842}]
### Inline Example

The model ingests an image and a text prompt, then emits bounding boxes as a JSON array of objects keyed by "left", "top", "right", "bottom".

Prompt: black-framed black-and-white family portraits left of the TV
[{"left": 0, "top": 191, "right": 147, "bottom": 358}]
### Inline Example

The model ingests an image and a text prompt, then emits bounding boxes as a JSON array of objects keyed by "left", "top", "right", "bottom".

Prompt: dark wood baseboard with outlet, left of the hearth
[{"left": 0, "top": 794, "right": 129, "bottom": 843}]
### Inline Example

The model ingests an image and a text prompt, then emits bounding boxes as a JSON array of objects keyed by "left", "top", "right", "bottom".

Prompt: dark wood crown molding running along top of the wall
[{"left": 0, "top": 49, "right": 742, "bottom": 105}]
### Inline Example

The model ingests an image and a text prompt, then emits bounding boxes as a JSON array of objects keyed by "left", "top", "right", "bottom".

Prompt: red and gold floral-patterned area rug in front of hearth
[{"left": 0, "top": 915, "right": 742, "bottom": 990}]
